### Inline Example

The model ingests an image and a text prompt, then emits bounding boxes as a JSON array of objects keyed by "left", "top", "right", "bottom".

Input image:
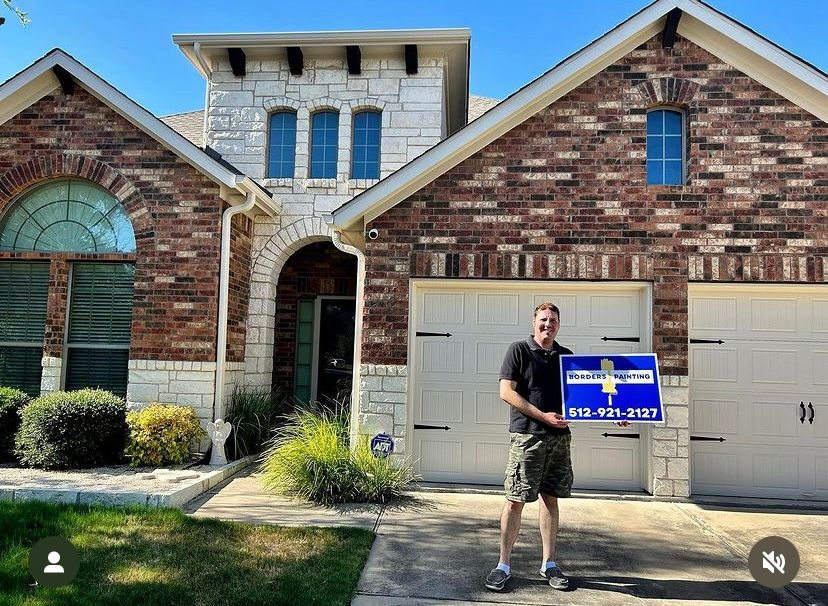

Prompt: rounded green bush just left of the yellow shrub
[{"left": 15, "top": 389, "right": 127, "bottom": 469}]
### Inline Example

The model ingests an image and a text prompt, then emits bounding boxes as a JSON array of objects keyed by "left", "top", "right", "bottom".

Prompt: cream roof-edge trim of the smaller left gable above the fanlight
[{"left": 0, "top": 48, "right": 281, "bottom": 215}]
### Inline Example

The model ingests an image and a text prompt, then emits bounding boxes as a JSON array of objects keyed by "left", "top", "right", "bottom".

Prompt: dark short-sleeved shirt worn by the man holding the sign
[{"left": 500, "top": 337, "right": 572, "bottom": 434}]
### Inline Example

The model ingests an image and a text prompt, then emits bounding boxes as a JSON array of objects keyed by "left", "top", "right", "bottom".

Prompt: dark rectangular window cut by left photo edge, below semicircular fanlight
[{"left": 0, "top": 262, "right": 49, "bottom": 396}]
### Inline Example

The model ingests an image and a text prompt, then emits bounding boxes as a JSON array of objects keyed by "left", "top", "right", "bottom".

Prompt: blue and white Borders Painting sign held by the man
[{"left": 561, "top": 354, "right": 664, "bottom": 423}]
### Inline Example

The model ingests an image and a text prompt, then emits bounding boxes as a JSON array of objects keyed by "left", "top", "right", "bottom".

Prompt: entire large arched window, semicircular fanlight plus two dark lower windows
[{"left": 0, "top": 179, "right": 136, "bottom": 396}]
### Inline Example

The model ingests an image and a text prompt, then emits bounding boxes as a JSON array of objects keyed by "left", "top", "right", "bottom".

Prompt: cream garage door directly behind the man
[{"left": 409, "top": 280, "right": 649, "bottom": 490}]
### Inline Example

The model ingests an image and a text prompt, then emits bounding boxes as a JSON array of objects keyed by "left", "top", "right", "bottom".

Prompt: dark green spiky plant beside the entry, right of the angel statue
[{"left": 224, "top": 387, "right": 286, "bottom": 460}]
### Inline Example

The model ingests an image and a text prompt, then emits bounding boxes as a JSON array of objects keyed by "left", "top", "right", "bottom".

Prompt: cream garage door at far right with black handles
[{"left": 689, "top": 285, "right": 828, "bottom": 499}]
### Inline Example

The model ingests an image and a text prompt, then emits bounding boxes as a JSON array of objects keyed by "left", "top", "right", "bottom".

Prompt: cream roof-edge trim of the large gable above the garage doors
[{"left": 326, "top": 0, "right": 828, "bottom": 231}]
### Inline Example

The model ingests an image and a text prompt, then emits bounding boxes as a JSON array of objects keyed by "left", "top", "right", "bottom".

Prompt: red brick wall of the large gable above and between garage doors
[{"left": 362, "top": 36, "right": 828, "bottom": 375}]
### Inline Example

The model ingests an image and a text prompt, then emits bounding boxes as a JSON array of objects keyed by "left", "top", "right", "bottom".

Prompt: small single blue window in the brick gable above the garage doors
[{"left": 647, "top": 109, "right": 684, "bottom": 185}]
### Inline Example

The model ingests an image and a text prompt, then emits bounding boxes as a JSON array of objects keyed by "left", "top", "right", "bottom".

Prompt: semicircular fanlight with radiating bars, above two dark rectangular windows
[{"left": 0, "top": 179, "right": 135, "bottom": 253}]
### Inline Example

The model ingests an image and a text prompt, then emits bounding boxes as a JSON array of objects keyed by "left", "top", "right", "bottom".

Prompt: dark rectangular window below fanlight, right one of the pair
[{"left": 66, "top": 263, "right": 135, "bottom": 397}]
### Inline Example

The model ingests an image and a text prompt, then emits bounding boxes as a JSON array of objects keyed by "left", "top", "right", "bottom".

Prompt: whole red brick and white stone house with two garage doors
[{"left": 0, "top": 0, "right": 828, "bottom": 499}]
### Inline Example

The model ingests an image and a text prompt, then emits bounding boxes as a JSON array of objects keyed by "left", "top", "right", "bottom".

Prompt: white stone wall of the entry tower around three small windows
[{"left": 205, "top": 55, "right": 456, "bottom": 385}]
